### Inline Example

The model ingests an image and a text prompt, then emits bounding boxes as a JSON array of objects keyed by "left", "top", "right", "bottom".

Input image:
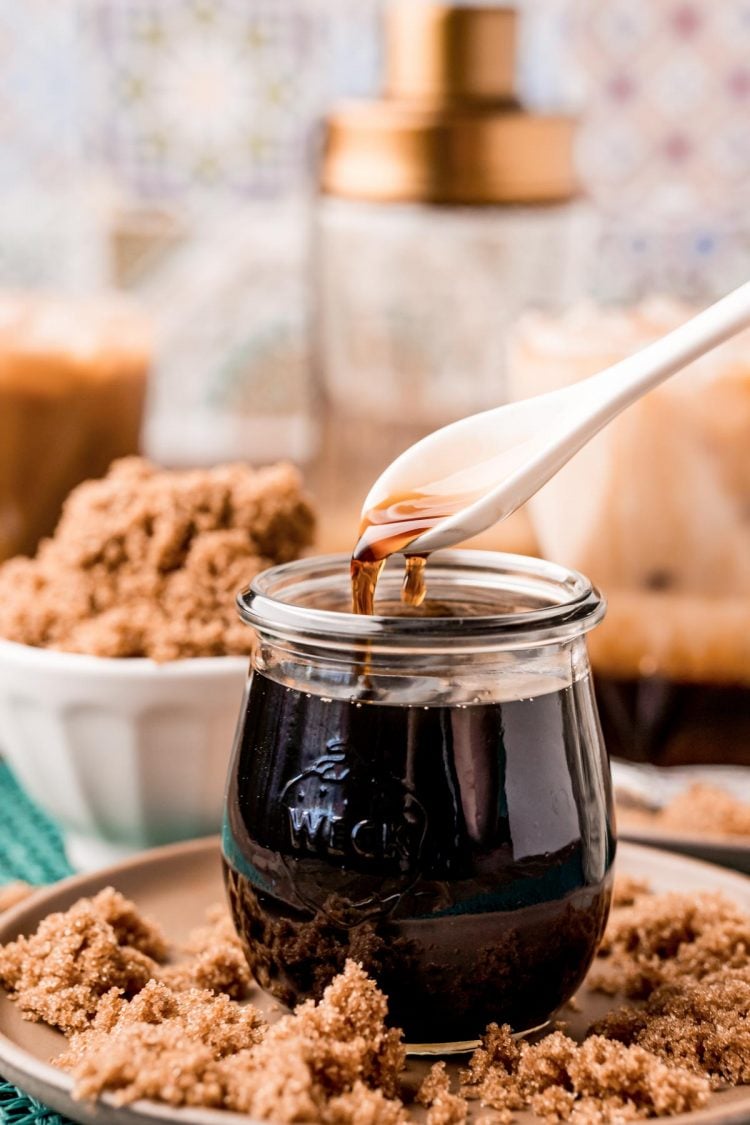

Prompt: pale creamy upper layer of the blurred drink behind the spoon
[{"left": 510, "top": 299, "right": 750, "bottom": 595}]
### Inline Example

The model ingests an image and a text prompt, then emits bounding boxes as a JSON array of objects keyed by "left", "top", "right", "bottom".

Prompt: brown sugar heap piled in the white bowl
[{"left": 0, "top": 457, "right": 314, "bottom": 660}]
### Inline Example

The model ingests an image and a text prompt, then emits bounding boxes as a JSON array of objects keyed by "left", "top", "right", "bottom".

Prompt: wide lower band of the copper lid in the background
[{"left": 322, "top": 100, "right": 576, "bottom": 204}]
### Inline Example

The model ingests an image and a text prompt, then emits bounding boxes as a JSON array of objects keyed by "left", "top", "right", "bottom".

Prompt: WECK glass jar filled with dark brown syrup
[{"left": 223, "top": 551, "right": 614, "bottom": 1051}]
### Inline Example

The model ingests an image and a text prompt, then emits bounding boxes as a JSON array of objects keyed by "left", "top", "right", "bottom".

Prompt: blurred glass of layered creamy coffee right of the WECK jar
[{"left": 509, "top": 298, "right": 750, "bottom": 765}]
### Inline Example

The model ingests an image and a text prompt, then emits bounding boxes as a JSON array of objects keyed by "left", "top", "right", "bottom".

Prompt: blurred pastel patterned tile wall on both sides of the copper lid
[{"left": 0, "top": 0, "right": 750, "bottom": 289}]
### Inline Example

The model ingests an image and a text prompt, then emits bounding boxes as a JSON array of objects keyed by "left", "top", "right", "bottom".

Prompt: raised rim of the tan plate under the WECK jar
[{"left": 0, "top": 836, "right": 750, "bottom": 1125}]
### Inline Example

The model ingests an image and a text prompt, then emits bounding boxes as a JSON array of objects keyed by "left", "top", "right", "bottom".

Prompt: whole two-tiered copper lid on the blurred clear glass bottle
[{"left": 320, "top": 0, "right": 576, "bottom": 204}]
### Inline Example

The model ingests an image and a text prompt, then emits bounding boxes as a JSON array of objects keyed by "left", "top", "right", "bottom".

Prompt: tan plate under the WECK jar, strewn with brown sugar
[{"left": 0, "top": 838, "right": 750, "bottom": 1125}]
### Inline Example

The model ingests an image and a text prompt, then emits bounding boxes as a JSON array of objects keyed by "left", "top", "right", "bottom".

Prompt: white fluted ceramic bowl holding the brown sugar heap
[{"left": 0, "top": 640, "right": 249, "bottom": 870}]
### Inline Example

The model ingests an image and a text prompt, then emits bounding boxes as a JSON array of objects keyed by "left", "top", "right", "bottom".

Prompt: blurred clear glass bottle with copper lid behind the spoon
[{"left": 318, "top": 0, "right": 588, "bottom": 544}]
